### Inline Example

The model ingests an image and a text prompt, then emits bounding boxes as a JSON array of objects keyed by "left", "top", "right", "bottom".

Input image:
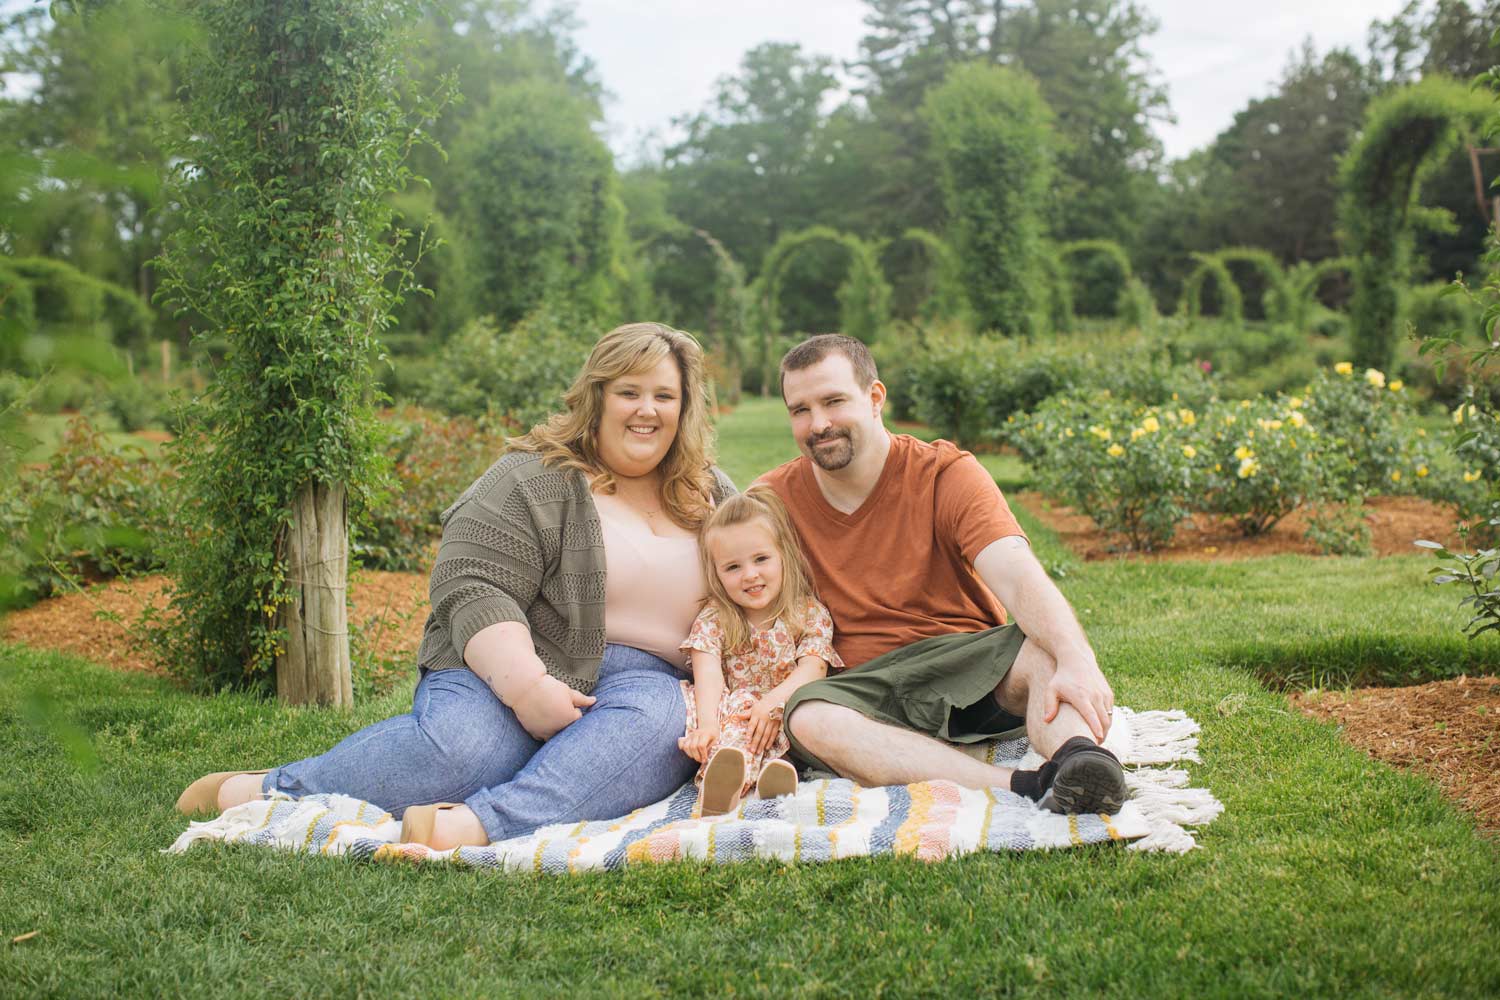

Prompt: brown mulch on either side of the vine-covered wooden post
[{"left": 0, "top": 570, "right": 428, "bottom": 675}]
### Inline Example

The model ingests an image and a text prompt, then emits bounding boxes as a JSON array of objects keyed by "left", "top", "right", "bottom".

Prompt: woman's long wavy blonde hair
[{"left": 506, "top": 322, "right": 714, "bottom": 528}]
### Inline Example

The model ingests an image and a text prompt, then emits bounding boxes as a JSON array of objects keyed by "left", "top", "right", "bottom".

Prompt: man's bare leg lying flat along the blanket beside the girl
[{"left": 786, "top": 702, "right": 1011, "bottom": 789}]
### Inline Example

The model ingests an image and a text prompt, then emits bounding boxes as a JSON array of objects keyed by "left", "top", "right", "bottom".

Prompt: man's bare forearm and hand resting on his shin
[{"left": 974, "top": 535, "right": 1115, "bottom": 742}]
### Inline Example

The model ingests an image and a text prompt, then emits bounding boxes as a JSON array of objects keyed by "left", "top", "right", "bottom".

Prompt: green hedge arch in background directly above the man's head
[{"left": 753, "top": 226, "right": 891, "bottom": 396}]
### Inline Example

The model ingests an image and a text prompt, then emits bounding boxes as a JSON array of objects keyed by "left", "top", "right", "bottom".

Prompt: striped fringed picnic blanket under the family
[{"left": 168, "top": 709, "right": 1223, "bottom": 873}]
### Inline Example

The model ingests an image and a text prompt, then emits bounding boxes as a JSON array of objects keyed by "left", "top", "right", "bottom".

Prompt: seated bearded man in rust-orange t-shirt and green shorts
[{"left": 762, "top": 334, "right": 1128, "bottom": 813}]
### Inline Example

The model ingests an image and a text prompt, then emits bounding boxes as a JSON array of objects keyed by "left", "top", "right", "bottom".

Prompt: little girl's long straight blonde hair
[{"left": 698, "top": 483, "right": 818, "bottom": 654}]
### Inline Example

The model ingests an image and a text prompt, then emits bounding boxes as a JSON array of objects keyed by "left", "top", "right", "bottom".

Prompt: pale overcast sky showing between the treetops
[{"left": 576, "top": 0, "right": 1406, "bottom": 157}]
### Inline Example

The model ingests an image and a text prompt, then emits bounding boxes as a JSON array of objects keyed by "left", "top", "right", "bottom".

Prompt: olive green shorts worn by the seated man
[{"left": 785, "top": 625, "right": 1026, "bottom": 774}]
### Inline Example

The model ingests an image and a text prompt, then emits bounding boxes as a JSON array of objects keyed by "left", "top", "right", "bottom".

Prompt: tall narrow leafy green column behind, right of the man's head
[{"left": 923, "top": 63, "right": 1053, "bottom": 336}]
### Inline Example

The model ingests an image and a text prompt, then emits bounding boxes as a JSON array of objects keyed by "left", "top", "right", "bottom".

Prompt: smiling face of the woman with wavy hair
[{"left": 594, "top": 355, "right": 683, "bottom": 478}]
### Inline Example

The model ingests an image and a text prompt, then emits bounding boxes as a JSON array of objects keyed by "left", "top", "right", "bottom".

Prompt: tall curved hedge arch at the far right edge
[{"left": 1338, "top": 78, "right": 1496, "bottom": 369}]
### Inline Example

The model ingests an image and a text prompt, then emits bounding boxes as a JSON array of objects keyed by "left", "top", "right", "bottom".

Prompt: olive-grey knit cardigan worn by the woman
[{"left": 417, "top": 451, "right": 735, "bottom": 694}]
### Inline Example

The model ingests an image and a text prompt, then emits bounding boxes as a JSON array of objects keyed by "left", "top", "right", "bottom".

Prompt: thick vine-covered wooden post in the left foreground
[{"left": 159, "top": 0, "right": 434, "bottom": 706}]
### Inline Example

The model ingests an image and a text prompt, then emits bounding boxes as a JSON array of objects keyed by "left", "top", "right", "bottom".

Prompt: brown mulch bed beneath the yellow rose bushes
[{"left": 1010, "top": 490, "right": 1458, "bottom": 561}]
